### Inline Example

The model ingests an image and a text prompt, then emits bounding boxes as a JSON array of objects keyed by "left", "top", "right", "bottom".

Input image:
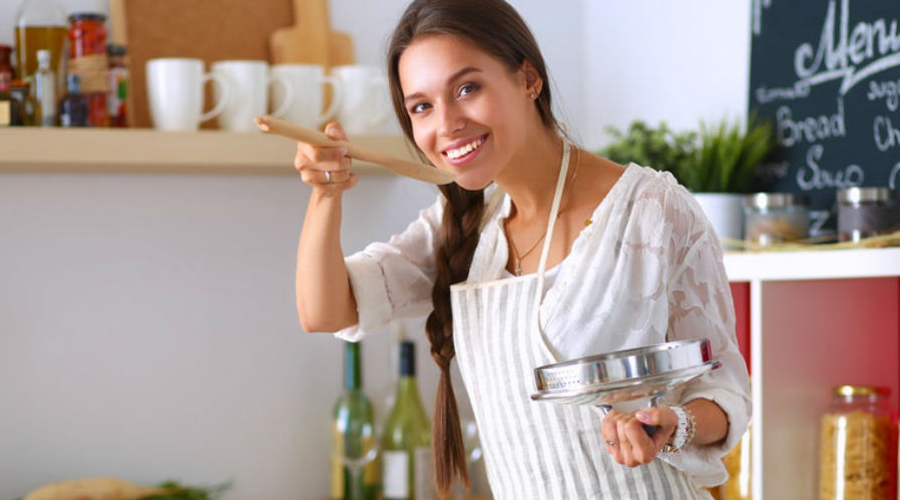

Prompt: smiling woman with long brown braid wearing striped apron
[{"left": 295, "top": 0, "right": 749, "bottom": 500}]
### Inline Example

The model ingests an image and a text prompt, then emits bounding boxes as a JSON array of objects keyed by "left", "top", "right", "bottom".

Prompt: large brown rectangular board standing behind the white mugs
[{"left": 110, "top": 0, "right": 293, "bottom": 128}]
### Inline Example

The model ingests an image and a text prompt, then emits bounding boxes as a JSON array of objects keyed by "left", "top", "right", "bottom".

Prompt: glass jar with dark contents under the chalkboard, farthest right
[{"left": 837, "top": 187, "right": 898, "bottom": 242}]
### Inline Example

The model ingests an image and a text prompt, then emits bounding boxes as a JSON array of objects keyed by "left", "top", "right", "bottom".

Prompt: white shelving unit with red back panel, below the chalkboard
[{"left": 725, "top": 248, "right": 900, "bottom": 500}]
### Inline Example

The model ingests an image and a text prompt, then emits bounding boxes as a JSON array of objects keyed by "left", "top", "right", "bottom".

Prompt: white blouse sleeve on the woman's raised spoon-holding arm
[{"left": 335, "top": 196, "right": 443, "bottom": 342}]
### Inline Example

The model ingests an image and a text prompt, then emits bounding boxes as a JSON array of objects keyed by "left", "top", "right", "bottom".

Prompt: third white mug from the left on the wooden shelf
[{"left": 272, "top": 64, "right": 342, "bottom": 128}]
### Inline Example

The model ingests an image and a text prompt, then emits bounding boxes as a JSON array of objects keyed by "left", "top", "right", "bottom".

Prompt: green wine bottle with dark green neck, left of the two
[{"left": 331, "top": 342, "right": 380, "bottom": 500}]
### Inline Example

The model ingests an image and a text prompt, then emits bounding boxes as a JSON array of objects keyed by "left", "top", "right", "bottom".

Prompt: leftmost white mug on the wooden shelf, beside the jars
[{"left": 146, "top": 57, "right": 233, "bottom": 131}]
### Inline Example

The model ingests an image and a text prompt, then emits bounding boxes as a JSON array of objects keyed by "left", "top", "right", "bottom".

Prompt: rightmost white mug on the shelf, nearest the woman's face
[{"left": 331, "top": 64, "right": 393, "bottom": 135}]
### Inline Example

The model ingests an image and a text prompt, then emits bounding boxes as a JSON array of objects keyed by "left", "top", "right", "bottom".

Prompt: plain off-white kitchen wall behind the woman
[{"left": 0, "top": 0, "right": 749, "bottom": 500}]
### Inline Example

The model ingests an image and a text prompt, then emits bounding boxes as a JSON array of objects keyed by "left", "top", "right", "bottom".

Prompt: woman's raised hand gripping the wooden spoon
[{"left": 294, "top": 122, "right": 359, "bottom": 194}]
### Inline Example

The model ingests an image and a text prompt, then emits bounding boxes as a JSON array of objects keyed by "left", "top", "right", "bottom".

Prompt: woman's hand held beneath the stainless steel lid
[{"left": 600, "top": 405, "right": 678, "bottom": 467}]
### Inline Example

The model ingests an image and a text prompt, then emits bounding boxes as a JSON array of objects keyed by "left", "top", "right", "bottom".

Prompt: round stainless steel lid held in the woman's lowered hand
[{"left": 531, "top": 339, "right": 721, "bottom": 405}]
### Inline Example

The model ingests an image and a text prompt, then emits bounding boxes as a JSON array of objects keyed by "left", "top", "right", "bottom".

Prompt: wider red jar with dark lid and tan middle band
[{"left": 69, "top": 12, "right": 109, "bottom": 127}]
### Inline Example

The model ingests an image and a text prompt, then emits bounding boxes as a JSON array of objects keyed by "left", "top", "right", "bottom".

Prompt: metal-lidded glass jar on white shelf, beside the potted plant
[{"left": 744, "top": 193, "right": 809, "bottom": 247}]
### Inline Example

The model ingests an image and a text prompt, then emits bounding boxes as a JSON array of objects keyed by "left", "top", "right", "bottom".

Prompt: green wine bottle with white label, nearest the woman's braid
[{"left": 381, "top": 341, "right": 435, "bottom": 500}]
